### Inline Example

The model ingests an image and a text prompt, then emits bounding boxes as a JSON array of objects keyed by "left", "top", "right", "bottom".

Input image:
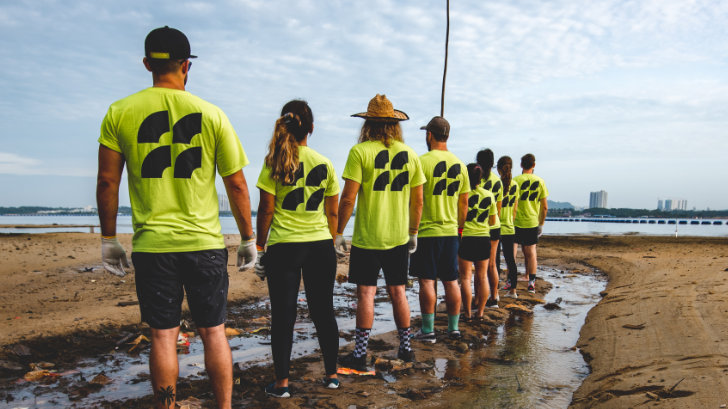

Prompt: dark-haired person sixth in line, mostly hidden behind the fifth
[{"left": 476, "top": 149, "right": 503, "bottom": 308}]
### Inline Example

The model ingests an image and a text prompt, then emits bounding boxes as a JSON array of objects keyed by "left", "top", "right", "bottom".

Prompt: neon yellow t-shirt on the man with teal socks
[{"left": 418, "top": 150, "right": 470, "bottom": 237}]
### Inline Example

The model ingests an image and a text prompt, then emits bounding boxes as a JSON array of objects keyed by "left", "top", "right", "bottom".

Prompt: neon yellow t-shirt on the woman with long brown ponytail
[{"left": 256, "top": 146, "right": 339, "bottom": 246}]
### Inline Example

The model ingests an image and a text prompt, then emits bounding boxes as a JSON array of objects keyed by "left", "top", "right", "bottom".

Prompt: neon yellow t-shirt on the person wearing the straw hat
[{"left": 342, "top": 141, "right": 425, "bottom": 250}]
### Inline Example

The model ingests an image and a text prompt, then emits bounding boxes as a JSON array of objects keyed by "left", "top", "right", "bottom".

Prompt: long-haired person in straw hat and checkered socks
[{"left": 335, "top": 94, "right": 425, "bottom": 370}]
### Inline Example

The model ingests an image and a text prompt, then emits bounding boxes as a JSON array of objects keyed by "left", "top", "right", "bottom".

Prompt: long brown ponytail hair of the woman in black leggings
[{"left": 265, "top": 100, "right": 313, "bottom": 185}]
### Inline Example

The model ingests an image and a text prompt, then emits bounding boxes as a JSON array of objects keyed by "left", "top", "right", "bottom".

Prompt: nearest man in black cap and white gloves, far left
[{"left": 96, "top": 26, "right": 256, "bottom": 408}]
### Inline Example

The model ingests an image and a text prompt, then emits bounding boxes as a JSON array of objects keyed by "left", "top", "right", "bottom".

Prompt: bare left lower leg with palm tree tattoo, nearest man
[{"left": 149, "top": 327, "right": 181, "bottom": 409}]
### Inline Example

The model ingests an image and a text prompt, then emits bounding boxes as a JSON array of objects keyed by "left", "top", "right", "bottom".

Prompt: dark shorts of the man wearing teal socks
[{"left": 410, "top": 236, "right": 459, "bottom": 281}]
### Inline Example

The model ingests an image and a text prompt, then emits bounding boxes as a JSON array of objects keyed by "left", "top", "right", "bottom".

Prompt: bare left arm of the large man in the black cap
[{"left": 96, "top": 145, "right": 124, "bottom": 237}]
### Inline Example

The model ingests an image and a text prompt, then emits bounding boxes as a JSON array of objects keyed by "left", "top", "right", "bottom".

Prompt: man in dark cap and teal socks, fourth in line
[{"left": 410, "top": 116, "right": 470, "bottom": 343}]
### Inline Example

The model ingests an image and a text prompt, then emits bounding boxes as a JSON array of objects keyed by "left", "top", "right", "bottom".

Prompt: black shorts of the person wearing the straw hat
[{"left": 349, "top": 244, "right": 409, "bottom": 286}]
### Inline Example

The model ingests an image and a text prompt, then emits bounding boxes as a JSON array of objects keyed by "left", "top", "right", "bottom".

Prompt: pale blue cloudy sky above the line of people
[{"left": 0, "top": 0, "right": 728, "bottom": 209}]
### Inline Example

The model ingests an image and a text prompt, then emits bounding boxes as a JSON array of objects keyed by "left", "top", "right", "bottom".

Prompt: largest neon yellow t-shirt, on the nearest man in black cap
[{"left": 99, "top": 88, "right": 248, "bottom": 253}]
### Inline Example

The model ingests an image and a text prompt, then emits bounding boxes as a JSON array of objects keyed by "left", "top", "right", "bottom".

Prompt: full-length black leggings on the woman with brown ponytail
[{"left": 262, "top": 239, "right": 339, "bottom": 380}]
